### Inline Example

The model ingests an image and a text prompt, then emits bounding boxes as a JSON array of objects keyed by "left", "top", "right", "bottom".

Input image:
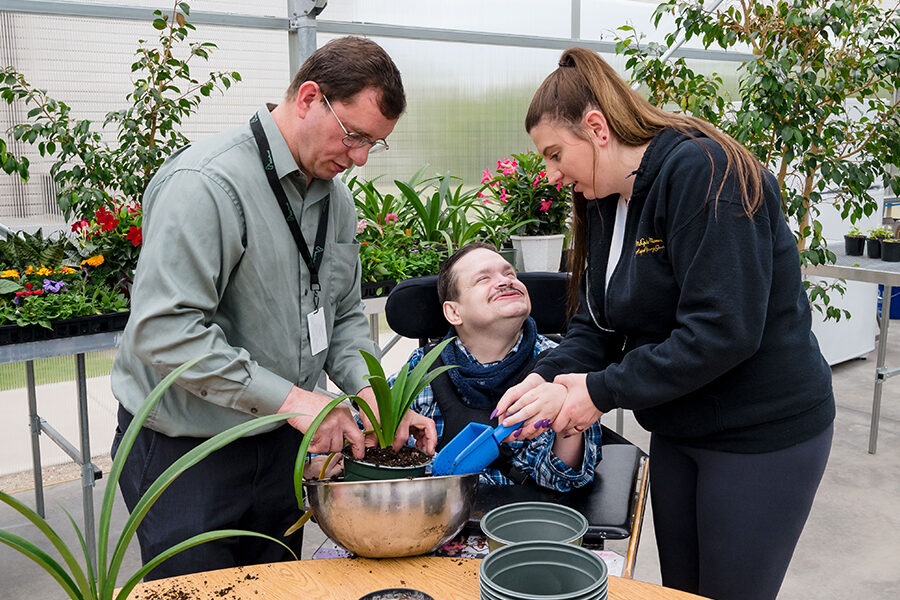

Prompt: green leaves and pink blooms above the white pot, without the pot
[{"left": 479, "top": 151, "right": 571, "bottom": 237}]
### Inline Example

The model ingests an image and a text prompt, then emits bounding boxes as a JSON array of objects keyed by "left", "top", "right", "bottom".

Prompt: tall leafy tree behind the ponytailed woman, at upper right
[{"left": 617, "top": 0, "right": 900, "bottom": 318}]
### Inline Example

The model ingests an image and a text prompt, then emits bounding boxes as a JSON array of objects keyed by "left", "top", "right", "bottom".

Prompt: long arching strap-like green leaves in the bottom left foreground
[{"left": 0, "top": 357, "right": 298, "bottom": 600}]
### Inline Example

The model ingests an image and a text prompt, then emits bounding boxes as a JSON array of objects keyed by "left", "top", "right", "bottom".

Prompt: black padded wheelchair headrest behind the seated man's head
[{"left": 384, "top": 272, "right": 568, "bottom": 339}]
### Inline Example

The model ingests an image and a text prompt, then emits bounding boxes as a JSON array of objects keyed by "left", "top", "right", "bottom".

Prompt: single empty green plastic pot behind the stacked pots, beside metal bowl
[{"left": 481, "top": 502, "right": 588, "bottom": 552}]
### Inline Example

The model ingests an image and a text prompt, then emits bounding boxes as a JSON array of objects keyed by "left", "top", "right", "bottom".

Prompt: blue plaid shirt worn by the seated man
[{"left": 388, "top": 335, "right": 600, "bottom": 492}]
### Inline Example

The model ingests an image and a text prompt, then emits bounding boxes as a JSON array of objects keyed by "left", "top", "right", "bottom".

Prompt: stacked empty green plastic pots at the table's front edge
[{"left": 478, "top": 542, "right": 609, "bottom": 600}]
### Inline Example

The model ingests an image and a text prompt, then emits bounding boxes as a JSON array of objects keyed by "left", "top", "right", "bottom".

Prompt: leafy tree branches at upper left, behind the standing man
[{"left": 0, "top": 2, "right": 241, "bottom": 219}]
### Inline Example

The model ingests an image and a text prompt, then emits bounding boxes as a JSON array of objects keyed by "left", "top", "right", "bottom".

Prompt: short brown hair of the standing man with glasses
[{"left": 285, "top": 36, "right": 406, "bottom": 120}]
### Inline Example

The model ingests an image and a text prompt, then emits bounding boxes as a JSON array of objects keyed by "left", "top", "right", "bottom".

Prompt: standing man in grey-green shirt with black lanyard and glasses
[{"left": 112, "top": 37, "right": 437, "bottom": 579}]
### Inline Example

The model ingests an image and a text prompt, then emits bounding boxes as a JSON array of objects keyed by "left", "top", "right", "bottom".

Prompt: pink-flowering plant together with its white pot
[{"left": 480, "top": 151, "right": 571, "bottom": 271}]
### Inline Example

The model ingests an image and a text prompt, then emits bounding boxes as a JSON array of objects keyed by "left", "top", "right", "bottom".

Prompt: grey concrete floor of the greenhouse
[{"left": 0, "top": 330, "right": 900, "bottom": 600}]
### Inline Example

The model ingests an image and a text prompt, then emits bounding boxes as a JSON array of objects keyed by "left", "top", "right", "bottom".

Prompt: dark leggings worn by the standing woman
[{"left": 650, "top": 426, "right": 834, "bottom": 600}]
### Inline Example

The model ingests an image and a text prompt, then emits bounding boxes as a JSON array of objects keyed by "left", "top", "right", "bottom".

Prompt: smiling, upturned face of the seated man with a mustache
[{"left": 444, "top": 248, "right": 531, "bottom": 332}]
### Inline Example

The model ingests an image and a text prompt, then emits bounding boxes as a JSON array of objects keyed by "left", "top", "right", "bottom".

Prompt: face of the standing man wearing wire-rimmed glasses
[{"left": 296, "top": 86, "right": 397, "bottom": 181}]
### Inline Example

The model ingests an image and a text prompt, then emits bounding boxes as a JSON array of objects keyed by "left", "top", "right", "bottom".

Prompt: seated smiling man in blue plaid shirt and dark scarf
[{"left": 390, "top": 243, "right": 601, "bottom": 491}]
